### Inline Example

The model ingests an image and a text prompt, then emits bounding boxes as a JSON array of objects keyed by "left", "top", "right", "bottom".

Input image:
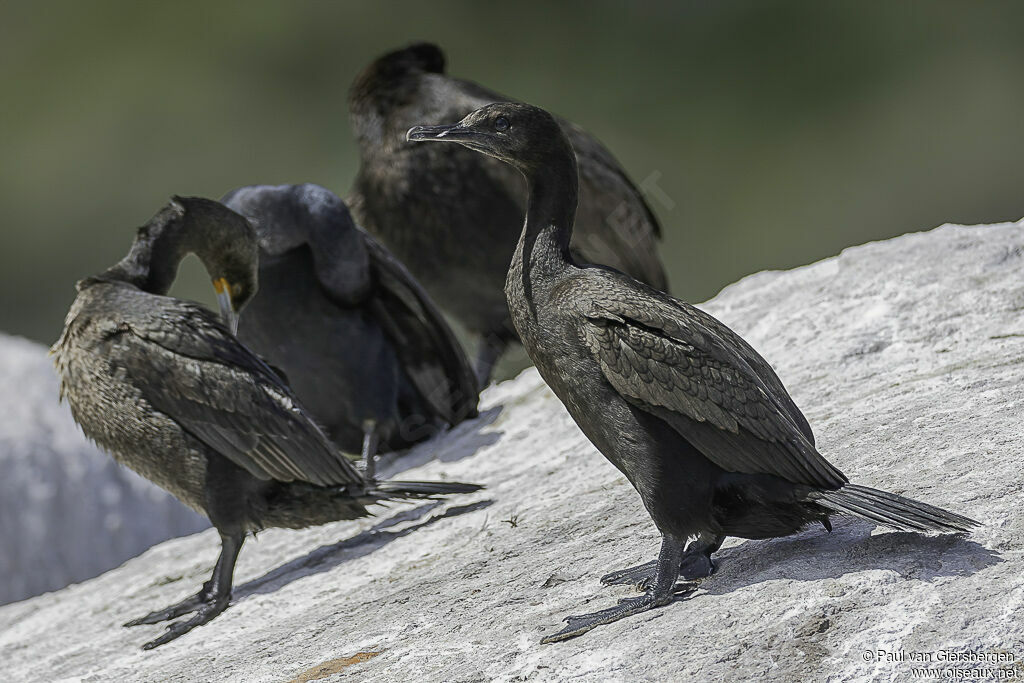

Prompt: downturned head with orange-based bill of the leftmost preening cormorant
[{"left": 168, "top": 197, "right": 259, "bottom": 334}]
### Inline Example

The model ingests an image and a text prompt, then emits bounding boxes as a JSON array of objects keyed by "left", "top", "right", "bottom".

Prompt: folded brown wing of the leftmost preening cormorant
[{"left": 108, "top": 297, "right": 362, "bottom": 486}]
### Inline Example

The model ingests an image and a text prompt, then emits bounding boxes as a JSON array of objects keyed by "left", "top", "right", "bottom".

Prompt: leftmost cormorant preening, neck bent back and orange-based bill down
[{"left": 52, "top": 198, "right": 479, "bottom": 649}]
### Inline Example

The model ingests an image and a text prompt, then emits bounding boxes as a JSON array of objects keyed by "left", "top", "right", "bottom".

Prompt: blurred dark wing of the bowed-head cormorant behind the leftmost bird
[{"left": 357, "top": 228, "right": 479, "bottom": 425}]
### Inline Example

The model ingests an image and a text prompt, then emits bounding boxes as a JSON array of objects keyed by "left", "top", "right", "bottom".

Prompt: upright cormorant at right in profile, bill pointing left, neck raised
[{"left": 408, "top": 102, "right": 977, "bottom": 642}]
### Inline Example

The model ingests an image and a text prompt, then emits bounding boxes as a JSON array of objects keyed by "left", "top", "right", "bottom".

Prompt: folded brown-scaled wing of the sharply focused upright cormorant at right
[{"left": 572, "top": 268, "right": 847, "bottom": 488}]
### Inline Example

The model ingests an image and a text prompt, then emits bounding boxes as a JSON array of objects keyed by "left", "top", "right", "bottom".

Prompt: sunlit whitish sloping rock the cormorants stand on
[{"left": 0, "top": 224, "right": 1024, "bottom": 681}]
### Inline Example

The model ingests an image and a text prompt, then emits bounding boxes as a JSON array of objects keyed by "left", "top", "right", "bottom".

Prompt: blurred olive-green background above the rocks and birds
[{"left": 0, "top": 0, "right": 1024, "bottom": 343}]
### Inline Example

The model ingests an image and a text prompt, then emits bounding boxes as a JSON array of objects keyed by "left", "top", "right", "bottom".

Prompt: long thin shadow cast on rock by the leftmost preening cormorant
[{"left": 233, "top": 500, "right": 494, "bottom": 600}]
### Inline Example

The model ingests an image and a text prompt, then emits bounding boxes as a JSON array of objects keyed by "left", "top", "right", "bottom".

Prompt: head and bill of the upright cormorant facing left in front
[{"left": 406, "top": 102, "right": 573, "bottom": 177}]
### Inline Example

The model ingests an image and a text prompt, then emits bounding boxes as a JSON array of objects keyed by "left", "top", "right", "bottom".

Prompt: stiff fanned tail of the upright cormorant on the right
[{"left": 811, "top": 483, "right": 979, "bottom": 531}]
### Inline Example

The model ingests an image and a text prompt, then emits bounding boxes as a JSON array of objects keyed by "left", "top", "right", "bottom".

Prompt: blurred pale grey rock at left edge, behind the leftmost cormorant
[{"left": 0, "top": 334, "right": 210, "bottom": 604}]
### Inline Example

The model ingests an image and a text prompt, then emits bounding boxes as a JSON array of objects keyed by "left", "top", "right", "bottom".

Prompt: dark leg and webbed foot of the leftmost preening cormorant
[{"left": 125, "top": 532, "right": 245, "bottom": 650}]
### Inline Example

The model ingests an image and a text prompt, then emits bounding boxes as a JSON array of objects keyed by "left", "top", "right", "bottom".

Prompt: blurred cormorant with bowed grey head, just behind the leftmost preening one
[{"left": 222, "top": 184, "right": 477, "bottom": 473}]
